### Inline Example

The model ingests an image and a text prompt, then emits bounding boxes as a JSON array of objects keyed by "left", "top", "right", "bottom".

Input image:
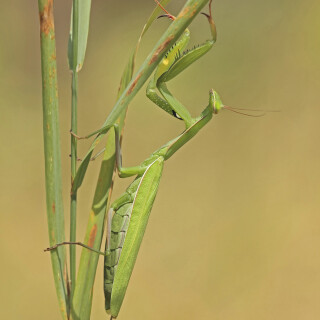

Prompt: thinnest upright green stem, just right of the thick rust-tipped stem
[{"left": 69, "top": 0, "right": 79, "bottom": 300}]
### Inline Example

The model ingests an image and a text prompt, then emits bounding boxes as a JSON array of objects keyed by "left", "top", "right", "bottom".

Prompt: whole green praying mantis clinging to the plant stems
[{"left": 46, "top": 0, "right": 260, "bottom": 319}]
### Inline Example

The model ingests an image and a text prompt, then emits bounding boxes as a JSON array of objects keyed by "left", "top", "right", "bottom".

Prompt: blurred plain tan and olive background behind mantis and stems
[{"left": 0, "top": 0, "right": 320, "bottom": 320}]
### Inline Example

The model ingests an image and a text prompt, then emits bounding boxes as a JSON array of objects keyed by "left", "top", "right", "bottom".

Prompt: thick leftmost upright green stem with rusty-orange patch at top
[{"left": 38, "top": 0, "right": 69, "bottom": 319}]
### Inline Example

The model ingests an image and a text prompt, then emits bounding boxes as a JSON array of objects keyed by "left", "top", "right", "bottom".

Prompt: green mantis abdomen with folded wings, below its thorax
[{"left": 104, "top": 156, "right": 164, "bottom": 317}]
